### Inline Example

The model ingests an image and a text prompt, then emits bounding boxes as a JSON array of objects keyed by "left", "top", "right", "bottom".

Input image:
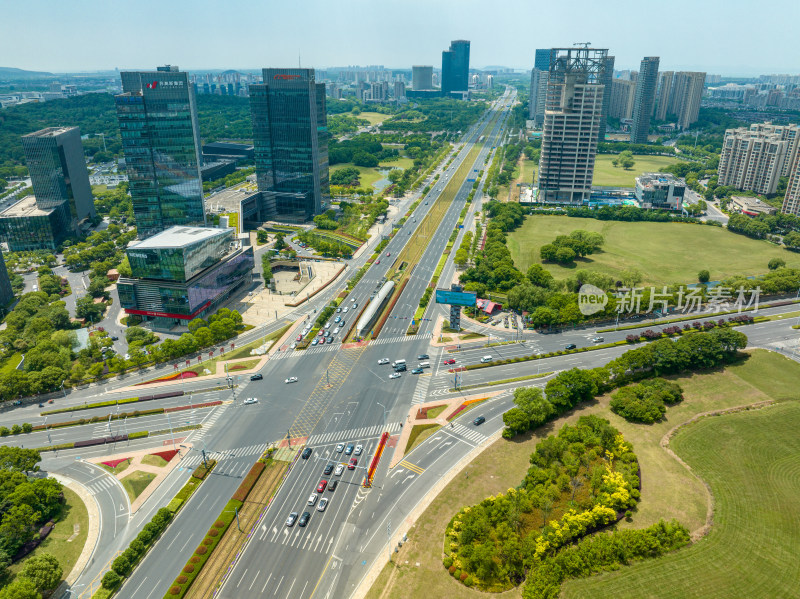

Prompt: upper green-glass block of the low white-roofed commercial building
[{"left": 126, "top": 228, "right": 234, "bottom": 283}]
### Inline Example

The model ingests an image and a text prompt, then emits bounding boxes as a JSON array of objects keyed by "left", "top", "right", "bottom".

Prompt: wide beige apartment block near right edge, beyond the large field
[{"left": 717, "top": 123, "right": 796, "bottom": 194}]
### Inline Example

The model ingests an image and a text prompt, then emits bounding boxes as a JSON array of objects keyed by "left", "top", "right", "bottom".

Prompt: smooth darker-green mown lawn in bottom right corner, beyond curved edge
[{"left": 564, "top": 401, "right": 800, "bottom": 599}]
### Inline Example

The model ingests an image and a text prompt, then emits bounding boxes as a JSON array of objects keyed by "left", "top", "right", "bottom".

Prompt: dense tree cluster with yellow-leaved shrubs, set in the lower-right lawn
[{"left": 444, "top": 416, "right": 639, "bottom": 590}]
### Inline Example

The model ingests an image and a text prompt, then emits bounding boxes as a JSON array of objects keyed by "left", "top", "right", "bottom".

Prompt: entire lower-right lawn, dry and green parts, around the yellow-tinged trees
[{"left": 367, "top": 350, "right": 800, "bottom": 599}]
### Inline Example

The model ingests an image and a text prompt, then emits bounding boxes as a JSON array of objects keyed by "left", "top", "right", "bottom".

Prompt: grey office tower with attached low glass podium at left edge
[{"left": 0, "top": 127, "right": 96, "bottom": 251}]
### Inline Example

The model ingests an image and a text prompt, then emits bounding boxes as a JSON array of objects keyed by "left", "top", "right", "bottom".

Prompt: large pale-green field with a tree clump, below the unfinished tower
[{"left": 508, "top": 215, "right": 800, "bottom": 285}]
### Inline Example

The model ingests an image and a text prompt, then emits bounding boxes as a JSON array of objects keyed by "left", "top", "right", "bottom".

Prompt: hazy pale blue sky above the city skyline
[{"left": 0, "top": 0, "right": 800, "bottom": 75}]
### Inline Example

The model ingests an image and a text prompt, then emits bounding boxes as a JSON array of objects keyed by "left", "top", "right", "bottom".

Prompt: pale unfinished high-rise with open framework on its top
[{"left": 539, "top": 48, "right": 608, "bottom": 204}]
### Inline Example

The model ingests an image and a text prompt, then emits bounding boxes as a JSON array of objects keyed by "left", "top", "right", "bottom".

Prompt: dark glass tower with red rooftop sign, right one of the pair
[{"left": 250, "top": 68, "right": 328, "bottom": 221}]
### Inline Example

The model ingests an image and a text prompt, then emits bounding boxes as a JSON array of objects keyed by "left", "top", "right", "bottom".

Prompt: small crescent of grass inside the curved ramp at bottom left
[{"left": 9, "top": 487, "right": 89, "bottom": 580}]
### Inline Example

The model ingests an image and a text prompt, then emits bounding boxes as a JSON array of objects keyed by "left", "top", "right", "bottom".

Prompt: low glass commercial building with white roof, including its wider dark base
[{"left": 117, "top": 226, "right": 255, "bottom": 329}]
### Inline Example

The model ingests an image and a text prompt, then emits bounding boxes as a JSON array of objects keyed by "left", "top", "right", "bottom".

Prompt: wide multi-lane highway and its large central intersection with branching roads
[{"left": 40, "top": 84, "right": 796, "bottom": 599}]
